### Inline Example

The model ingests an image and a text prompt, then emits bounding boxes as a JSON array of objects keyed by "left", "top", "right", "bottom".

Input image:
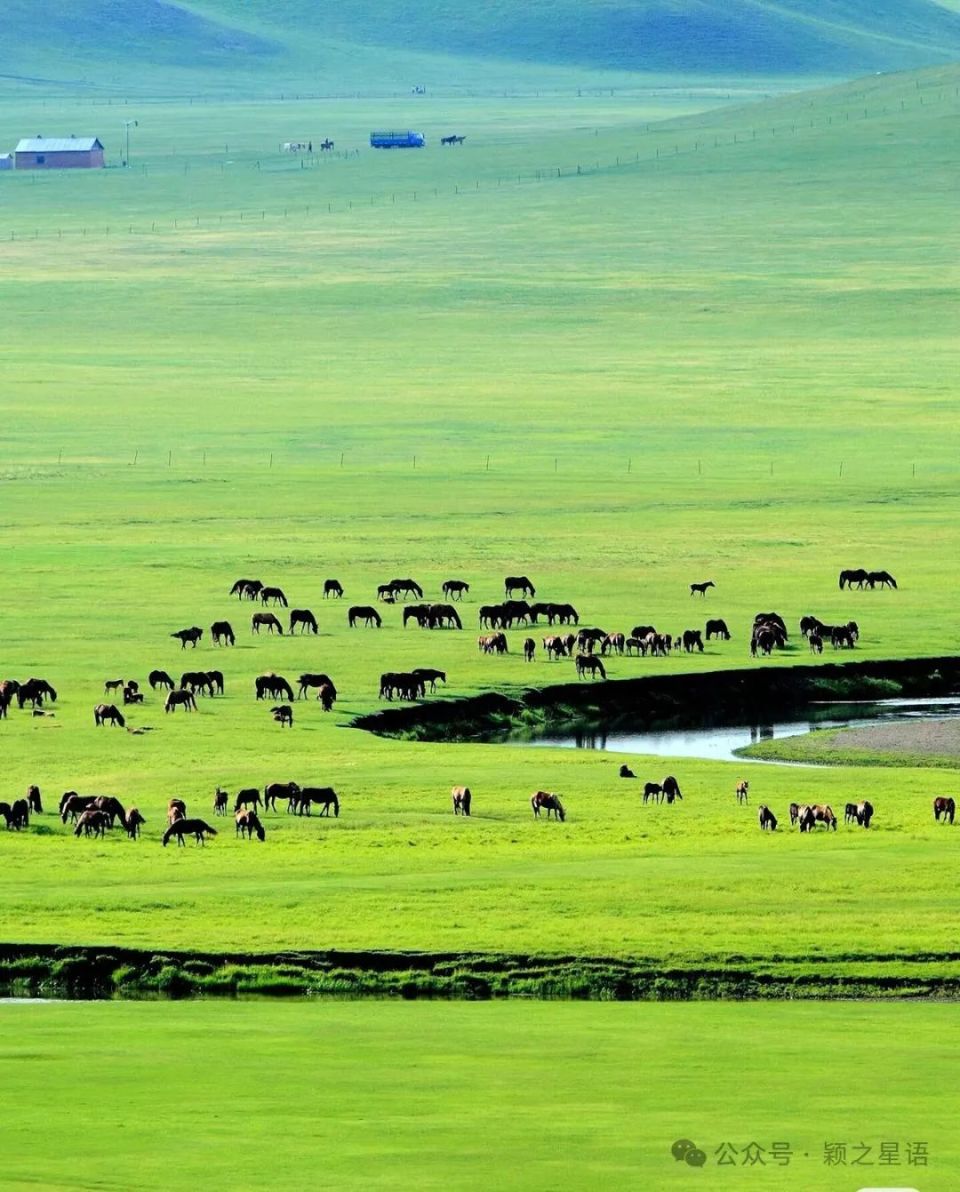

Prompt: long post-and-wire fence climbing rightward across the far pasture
[{"left": 0, "top": 86, "right": 960, "bottom": 242}]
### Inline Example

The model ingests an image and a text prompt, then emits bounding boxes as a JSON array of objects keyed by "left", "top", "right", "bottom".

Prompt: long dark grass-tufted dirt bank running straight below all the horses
[{"left": 0, "top": 944, "right": 960, "bottom": 1001}]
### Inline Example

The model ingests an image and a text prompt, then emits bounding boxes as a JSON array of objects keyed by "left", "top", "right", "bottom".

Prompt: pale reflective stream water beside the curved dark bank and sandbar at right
[{"left": 519, "top": 696, "right": 960, "bottom": 764}]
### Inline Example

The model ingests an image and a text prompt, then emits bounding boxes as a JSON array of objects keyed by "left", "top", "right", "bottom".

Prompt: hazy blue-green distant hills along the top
[{"left": 0, "top": 0, "right": 960, "bottom": 89}]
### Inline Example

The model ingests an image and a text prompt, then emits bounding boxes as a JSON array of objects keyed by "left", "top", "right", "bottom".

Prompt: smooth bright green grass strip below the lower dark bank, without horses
[{"left": 0, "top": 1001, "right": 960, "bottom": 1192}]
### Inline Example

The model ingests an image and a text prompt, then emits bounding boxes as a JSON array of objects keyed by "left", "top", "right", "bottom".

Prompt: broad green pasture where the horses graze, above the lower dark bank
[{"left": 0, "top": 70, "right": 960, "bottom": 973}]
